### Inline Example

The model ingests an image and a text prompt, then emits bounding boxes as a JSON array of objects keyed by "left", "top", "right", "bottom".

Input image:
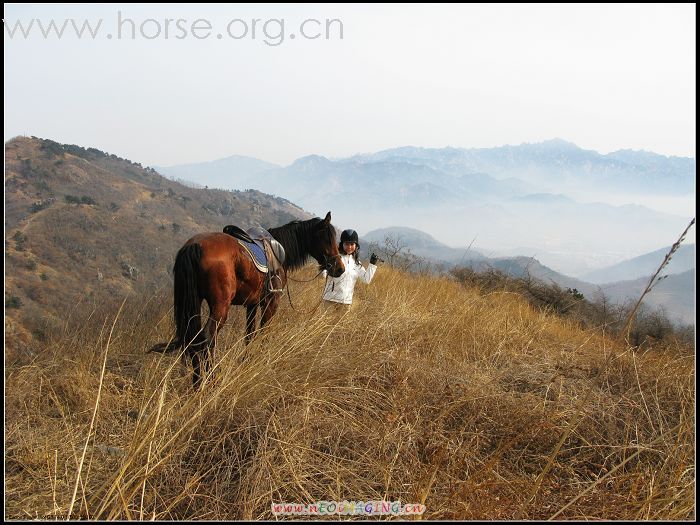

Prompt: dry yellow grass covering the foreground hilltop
[{"left": 5, "top": 267, "right": 695, "bottom": 520}]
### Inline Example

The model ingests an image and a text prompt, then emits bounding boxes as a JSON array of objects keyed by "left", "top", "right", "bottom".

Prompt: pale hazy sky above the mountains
[{"left": 4, "top": 4, "right": 695, "bottom": 165}]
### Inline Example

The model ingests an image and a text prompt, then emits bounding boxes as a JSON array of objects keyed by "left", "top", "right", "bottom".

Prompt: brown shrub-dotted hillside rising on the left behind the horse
[{"left": 5, "top": 137, "right": 310, "bottom": 353}]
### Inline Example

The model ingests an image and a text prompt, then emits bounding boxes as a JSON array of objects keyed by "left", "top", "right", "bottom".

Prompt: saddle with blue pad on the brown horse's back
[{"left": 224, "top": 224, "right": 287, "bottom": 293}]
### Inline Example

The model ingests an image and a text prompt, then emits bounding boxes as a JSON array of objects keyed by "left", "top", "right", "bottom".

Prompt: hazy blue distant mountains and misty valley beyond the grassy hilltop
[{"left": 159, "top": 139, "right": 695, "bottom": 275}]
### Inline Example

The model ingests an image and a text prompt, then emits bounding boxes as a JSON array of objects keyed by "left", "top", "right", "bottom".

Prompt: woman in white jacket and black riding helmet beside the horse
[{"left": 323, "top": 230, "right": 379, "bottom": 305}]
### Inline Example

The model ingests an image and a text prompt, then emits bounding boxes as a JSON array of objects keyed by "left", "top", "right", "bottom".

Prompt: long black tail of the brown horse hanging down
[{"left": 173, "top": 243, "right": 202, "bottom": 354}]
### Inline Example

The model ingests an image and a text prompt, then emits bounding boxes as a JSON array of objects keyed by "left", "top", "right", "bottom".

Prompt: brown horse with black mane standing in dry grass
[{"left": 150, "top": 212, "right": 345, "bottom": 390}]
